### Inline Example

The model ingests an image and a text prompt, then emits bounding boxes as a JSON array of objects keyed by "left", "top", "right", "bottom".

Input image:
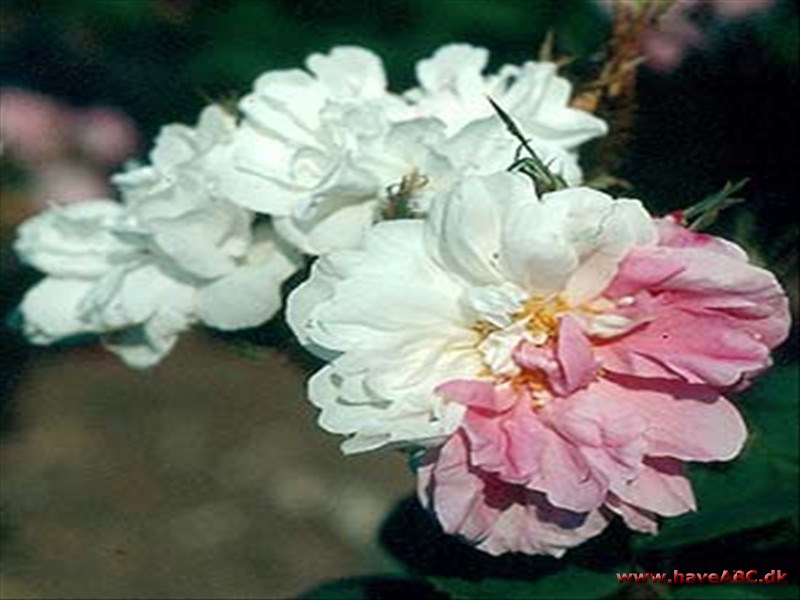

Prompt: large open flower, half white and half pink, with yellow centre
[{"left": 288, "top": 173, "right": 788, "bottom": 556}]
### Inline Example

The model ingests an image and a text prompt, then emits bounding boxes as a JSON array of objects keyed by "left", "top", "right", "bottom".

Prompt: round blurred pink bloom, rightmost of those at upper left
[{"left": 72, "top": 106, "right": 140, "bottom": 167}]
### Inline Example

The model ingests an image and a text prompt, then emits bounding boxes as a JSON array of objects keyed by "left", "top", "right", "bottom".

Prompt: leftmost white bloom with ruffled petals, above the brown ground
[{"left": 16, "top": 106, "right": 301, "bottom": 367}]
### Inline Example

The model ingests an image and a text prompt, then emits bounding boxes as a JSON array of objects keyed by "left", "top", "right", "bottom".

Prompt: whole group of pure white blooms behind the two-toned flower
[{"left": 16, "top": 45, "right": 606, "bottom": 367}]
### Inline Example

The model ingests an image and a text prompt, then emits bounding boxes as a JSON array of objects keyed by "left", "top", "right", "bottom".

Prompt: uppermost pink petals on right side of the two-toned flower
[{"left": 598, "top": 232, "right": 789, "bottom": 387}]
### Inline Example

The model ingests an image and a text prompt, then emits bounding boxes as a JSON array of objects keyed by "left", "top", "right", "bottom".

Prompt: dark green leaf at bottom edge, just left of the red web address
[{"left": 430, "top": 566, "right": 620, "bottom": 600}]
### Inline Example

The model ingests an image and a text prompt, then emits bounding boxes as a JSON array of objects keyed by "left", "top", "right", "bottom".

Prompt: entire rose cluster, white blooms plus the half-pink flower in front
[{"left": 12, "top": 45, "right": 789, "bottom": 556}]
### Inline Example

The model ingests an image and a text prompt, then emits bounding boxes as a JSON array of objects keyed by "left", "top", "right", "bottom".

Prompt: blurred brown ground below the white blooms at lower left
[{"left": 0, "top": 334, "right": 413, "bottom": 599}]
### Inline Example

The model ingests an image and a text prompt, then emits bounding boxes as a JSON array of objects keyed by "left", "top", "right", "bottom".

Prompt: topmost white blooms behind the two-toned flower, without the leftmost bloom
[{"left": 221, "top": 45, "right": 606, "bottom": 255}]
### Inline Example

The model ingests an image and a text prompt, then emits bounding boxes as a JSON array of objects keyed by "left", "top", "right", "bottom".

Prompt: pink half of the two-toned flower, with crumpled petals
[{"left": 419, "top": 219, "right": 789, "bottom": 556}]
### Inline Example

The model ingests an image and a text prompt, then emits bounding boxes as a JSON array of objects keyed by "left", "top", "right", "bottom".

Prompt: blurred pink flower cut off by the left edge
[{"left": 0, "top": 88, "right": 70, "bottom": 163}]
